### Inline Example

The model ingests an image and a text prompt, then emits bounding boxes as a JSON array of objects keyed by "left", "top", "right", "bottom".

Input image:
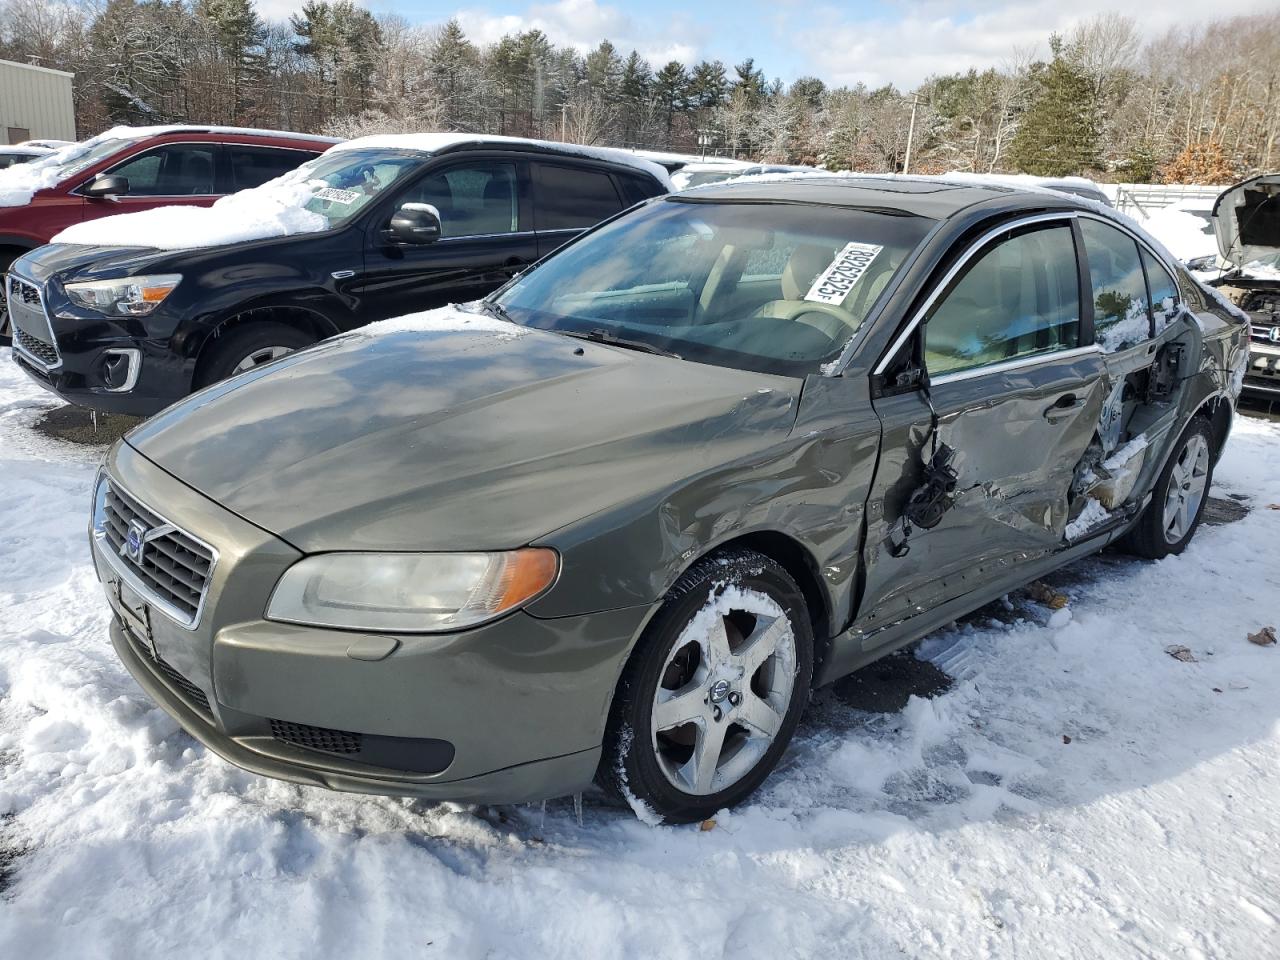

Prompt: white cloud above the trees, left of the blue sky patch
[{"left": 456, "top": 0, "right": 708, "bottom": 68}]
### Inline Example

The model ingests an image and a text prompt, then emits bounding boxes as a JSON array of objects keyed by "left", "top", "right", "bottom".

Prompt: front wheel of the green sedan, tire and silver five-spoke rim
[{"left": 600, "top": 550, "right": 813, "bottom": 823}]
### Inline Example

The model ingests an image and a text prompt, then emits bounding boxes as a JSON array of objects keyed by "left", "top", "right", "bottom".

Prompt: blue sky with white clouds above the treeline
[{"left": 259, "top": 0, "right": 1275, "bottom": 88}]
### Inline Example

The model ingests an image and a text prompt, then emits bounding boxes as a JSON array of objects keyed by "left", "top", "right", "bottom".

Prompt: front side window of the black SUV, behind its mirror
[{"left": 396, "top": 160, "right": 521, "bottom": 237}]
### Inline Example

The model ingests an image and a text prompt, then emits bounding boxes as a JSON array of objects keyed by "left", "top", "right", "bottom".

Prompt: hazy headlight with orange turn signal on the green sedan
[{"left": 266, "top": 547, "right": 559, "bottom": 634}]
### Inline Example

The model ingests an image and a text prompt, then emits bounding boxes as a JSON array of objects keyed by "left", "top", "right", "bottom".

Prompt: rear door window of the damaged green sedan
[{"left": 1079, "top": 216, "right": 1151, "bottom": 353}]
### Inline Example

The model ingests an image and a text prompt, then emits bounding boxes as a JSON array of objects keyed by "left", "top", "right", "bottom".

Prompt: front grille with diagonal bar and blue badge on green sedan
[{"left": 102, "top": 483, "right": 214, "bottom": 626}]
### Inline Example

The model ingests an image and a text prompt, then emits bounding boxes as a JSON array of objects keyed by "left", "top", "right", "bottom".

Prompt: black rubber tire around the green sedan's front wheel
[{"left": 596, "top": 550, "right": 814, "bottom": 823}]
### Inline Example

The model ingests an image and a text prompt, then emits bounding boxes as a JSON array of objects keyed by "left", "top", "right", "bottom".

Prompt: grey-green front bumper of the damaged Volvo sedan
[{"left": 92, "top": 444, "right": 646, "bottom": 803}]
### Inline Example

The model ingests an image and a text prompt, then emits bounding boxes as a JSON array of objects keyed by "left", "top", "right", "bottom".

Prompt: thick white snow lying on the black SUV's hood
[{"left": 51, "top": 170, "right": 329, "bottom": 250}]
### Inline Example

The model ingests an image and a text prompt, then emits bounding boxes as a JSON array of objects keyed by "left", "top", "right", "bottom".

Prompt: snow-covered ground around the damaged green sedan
[{"left": 0, "top": 351, "right": 1280, "bottom": 960}]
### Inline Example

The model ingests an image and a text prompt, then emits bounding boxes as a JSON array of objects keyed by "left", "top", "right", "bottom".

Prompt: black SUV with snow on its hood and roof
[{"left": 8, "top": 134, "right": 669, "bottom": 415}]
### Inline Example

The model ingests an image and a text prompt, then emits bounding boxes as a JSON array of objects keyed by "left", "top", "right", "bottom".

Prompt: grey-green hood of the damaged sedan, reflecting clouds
[{"left": 125, "top": 311, "right": 801, "bottom": 552}]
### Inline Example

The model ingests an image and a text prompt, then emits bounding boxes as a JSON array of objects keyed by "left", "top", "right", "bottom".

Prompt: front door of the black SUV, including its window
[{"left": 360, "top": 157, "right": 538, "bottom": 323}]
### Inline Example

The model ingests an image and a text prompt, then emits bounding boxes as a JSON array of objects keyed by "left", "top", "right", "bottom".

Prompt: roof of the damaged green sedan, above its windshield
[{"left": 675, "top": 174, "right": 1070, "bottom": 220}]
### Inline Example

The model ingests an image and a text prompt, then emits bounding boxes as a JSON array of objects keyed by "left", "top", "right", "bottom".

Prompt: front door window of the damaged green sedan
[{"left": 924, "top": 225, "right": 1080, "bottom": 376}]
